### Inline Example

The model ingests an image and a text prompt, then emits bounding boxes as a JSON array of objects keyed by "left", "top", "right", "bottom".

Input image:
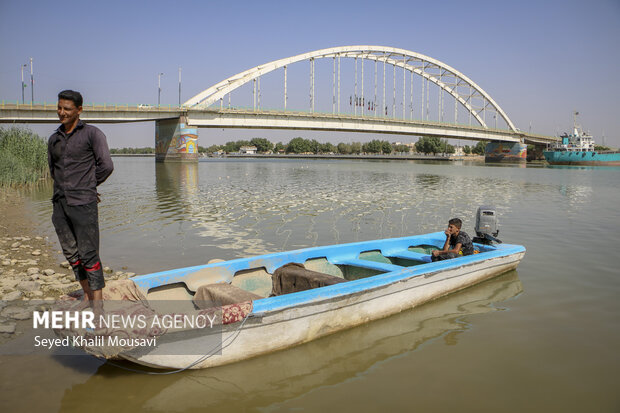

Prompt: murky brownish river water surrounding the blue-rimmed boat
[{"left": 0, "top": 158, "right": 620, "bottom": 413}]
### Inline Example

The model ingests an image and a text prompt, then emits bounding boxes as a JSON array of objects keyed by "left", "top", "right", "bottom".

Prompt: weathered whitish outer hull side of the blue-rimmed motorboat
[{"left": 120, "top": 250, "right": 525, "bottom": 369}]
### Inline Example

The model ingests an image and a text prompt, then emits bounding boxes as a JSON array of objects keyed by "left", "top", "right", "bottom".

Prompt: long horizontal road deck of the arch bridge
[{"left": 0, "top": 102, "right": 558, "bottom": 144}]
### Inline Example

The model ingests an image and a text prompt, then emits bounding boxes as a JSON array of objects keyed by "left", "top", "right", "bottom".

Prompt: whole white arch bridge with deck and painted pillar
[{"left": 0, "top": 45, "right": 556, "bottom": 160}]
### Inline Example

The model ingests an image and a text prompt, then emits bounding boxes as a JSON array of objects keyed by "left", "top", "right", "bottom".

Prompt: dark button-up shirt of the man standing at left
[{"left": 47, "top": 120, "right": 114, "bottom": 205}]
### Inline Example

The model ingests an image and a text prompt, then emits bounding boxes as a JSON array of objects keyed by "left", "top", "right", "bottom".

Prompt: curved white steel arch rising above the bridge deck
[{"left": 184, "top": 46, "right": 517, "bottom": 132}]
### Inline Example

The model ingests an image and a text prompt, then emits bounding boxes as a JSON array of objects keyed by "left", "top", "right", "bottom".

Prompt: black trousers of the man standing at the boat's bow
[{"left": 52, "top": 197, "right": 105, "bottom": 291}]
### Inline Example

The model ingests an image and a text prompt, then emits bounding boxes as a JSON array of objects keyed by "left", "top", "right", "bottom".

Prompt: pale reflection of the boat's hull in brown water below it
[{"left": 62, "top": 271, "right": 522, "bottom": 411}]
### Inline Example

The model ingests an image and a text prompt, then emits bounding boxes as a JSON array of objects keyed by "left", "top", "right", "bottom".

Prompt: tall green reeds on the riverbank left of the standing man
[{"left": 0, "top": 127, "right": 49, "bottom": 187}]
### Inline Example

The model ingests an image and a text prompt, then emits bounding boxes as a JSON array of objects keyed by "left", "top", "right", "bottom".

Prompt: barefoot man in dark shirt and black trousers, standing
[{"left": 47, "top": 90, "right": 114, "bottom": 301}]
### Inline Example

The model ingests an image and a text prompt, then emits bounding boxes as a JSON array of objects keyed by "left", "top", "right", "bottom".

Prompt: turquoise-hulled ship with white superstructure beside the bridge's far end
[{"left": 543, "top": 112, "right": 620, "bottom": 166}]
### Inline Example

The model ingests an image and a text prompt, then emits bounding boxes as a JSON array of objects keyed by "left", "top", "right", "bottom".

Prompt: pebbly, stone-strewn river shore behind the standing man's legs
[{"left": 0, "top": 189, "right": 135, "bottom": 336}]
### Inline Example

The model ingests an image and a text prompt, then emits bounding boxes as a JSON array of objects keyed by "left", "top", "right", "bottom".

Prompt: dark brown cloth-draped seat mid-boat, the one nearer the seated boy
[{"left": 271, "top": 262, "right": 347, "bottom": 296}]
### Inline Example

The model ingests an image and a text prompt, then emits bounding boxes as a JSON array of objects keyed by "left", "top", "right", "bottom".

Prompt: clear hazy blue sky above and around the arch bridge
[{"left": 0, "top": 0, "right": 620, "bottom": 147}]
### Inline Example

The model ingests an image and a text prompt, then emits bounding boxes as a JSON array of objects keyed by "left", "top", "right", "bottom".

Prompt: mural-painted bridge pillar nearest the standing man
[{"left": 155, "top": 116, "right": 198, "bottom": 162}]
